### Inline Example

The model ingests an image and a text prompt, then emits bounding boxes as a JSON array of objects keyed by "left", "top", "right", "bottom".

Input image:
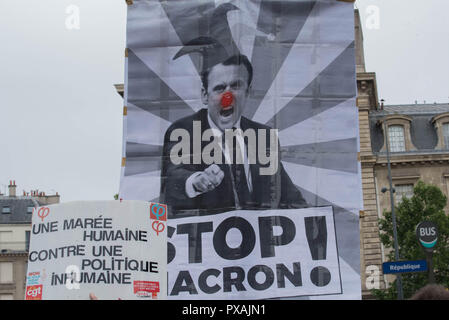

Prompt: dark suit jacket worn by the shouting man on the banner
[{"left": 160, "top": 109, "right": 307, "bottom": 215}]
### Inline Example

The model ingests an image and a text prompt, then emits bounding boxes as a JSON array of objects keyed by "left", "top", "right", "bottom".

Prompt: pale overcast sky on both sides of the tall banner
[{"left": 0, "top": 0, "right": 449, "bottom": 202}]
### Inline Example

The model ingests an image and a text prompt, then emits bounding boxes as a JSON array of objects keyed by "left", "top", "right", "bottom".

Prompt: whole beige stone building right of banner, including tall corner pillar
[{"left": 355, "top": 11, "right": 449, "bottom": 299}]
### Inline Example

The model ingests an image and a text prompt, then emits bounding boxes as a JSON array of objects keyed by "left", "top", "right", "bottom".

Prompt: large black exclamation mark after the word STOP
[{"left": 304, "top": 216, "right": 331, "bottom": 287}]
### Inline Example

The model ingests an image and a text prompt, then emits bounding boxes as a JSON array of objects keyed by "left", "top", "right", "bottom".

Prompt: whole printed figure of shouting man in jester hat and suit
[{"left": 161, "top": 4, "right": 307, "bottom": 214}]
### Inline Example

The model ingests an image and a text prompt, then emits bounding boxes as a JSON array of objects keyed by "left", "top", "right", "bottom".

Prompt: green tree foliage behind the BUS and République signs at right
[{"left": 372, "top": 181, "right": 449, "bottom": 299}]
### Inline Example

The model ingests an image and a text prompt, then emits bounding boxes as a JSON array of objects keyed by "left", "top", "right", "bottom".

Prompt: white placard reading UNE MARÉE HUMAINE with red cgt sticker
[{"left": 25, "top": 201, "right": 167, "bottom": 300}]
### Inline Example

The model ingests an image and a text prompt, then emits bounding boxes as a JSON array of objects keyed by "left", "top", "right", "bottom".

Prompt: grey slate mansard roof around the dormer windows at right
[{"left": 369, "top": 103, "right": 449, "bottom": 153}]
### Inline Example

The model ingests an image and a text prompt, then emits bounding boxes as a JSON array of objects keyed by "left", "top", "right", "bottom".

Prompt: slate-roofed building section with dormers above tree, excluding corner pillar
[{"left": 369, "top": 104, "right": 449, "bottom": 285}]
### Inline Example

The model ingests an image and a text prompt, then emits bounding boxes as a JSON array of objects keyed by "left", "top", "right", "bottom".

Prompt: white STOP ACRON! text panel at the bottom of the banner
[{"left": 168, "top": 207, "right": 343, "bottom": 299}]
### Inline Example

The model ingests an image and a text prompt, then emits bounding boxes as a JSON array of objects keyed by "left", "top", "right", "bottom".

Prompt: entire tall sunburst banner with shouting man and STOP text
[{"left": 119, "top": 0, "right": 362, "bottom": 299}]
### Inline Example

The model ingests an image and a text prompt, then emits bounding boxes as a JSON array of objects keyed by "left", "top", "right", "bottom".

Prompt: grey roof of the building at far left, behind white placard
[{"left": 0, "top": 196, "right": 41, "bottom": 224}]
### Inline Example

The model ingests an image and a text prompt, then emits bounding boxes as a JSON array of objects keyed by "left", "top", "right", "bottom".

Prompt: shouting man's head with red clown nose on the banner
[{"left": 201, "top": 55, "right": 253, "bottom": 130}]
